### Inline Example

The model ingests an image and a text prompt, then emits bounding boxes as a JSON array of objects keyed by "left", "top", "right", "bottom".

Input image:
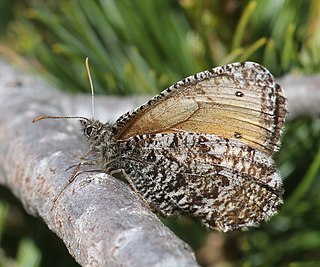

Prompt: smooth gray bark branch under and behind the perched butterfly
[{"left": 0, "top": 60, "right": 320, "bottom": 266}]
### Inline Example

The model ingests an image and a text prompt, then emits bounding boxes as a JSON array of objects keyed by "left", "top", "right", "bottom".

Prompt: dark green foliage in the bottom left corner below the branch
[{"left": 0, "top": 193, "right": 79, "bottom": 267}]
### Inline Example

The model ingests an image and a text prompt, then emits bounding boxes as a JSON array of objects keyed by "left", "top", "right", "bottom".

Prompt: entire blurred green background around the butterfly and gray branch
[{"left": 0, "top": 0, "right": 320, "bottom": 266}]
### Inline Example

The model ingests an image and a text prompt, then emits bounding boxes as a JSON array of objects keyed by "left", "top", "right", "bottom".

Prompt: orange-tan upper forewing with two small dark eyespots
[{"left": 114, "top": 62, "right": 286, "bottom": 155}]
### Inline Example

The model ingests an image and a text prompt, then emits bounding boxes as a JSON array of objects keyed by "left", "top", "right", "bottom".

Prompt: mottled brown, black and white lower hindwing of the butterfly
[{"left": 116, "top": 132, "right": 282, "bottom": 231}]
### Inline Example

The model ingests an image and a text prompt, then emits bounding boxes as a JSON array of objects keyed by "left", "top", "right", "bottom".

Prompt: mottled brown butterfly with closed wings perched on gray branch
[{"left": 33, "top": 62, "right": 286, "bottom": 232}]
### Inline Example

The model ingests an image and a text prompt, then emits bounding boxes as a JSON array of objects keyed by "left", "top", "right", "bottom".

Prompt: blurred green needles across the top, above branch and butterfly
[{"left": 5, "top": 0, "right": 320, "bottom": 94}]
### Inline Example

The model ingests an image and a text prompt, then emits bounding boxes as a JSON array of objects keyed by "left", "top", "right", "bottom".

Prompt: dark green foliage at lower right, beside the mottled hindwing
[{"left": 242, "top": 119, "right": 320, "bottom": 266}]
